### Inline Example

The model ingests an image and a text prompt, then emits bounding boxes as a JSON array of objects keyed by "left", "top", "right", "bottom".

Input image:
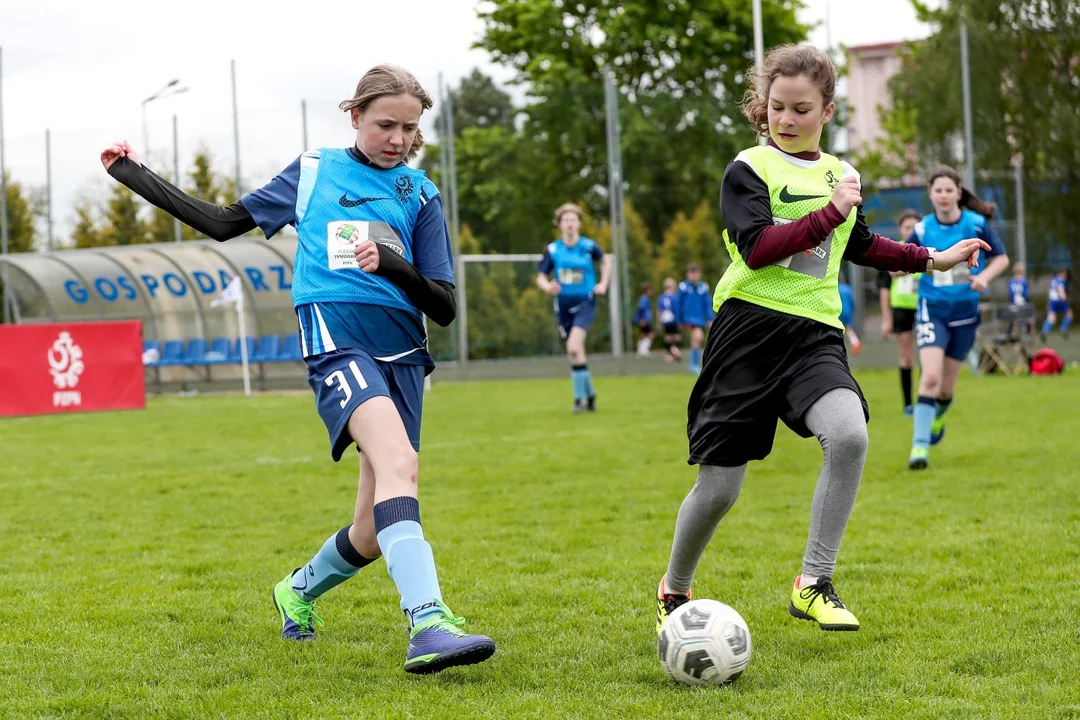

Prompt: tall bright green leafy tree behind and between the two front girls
[{"left": 476, "top": 0, "right": 806, "bottom": 236}]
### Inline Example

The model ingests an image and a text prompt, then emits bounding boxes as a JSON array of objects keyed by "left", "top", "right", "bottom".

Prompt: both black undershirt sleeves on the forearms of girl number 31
[{"left": 108, "top": 158, "right": 458, "bottom": 327}]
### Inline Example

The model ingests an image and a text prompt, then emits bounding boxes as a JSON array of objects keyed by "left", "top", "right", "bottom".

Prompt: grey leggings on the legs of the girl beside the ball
[{"left": 665, "top": 388, "right": 867, "bottom": 593}]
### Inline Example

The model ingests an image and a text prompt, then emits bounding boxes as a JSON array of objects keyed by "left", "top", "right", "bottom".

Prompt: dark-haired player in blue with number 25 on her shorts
[{"left": 908, "top": 166, "right": 1009, "bottom": 470}]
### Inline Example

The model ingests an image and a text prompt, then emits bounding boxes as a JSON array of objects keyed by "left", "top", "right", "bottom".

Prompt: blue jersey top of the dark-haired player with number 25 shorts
[{"left": 907, "top": 209, "right": 1005, "bottom": 314}]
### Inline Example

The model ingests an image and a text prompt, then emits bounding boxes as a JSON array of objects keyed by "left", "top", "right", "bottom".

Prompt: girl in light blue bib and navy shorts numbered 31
[{"left": 102, "top": 65, "right": 495, "bottom": 674}]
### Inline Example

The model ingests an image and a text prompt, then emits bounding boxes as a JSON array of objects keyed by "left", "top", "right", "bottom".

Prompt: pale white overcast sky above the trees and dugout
[{"left": 0, "top": 0, "right": 929, "bottom": 243}]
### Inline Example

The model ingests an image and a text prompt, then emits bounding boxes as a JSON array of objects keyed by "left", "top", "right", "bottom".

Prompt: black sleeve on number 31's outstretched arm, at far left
[{"left": 108, "top": 158, "right": 256, "bottom": 242}]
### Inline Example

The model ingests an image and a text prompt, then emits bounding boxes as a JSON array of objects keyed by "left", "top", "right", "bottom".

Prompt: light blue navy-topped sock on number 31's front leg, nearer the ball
[{"left": 375, "top": 495, "right": 443, "bottom": 625}]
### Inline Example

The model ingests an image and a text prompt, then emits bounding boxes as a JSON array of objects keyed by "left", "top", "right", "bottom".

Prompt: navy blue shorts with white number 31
[{"left": 307, "top": 348, "right": 424, "bottom": 462}]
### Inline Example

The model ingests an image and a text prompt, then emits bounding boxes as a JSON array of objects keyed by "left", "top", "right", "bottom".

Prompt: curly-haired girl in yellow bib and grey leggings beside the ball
[{"left": 657, "top": 45, "right": 986, "bottom": 630}]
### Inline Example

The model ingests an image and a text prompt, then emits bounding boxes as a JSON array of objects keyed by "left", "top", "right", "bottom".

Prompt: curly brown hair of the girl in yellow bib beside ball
[{"left": 742, "top": 45, "right": 836, "bottom": 137}]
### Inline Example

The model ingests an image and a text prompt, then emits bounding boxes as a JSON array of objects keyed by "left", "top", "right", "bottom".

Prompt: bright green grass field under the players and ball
[{"left": 0, "top": 372, "right": 1080, "bottom": 720}]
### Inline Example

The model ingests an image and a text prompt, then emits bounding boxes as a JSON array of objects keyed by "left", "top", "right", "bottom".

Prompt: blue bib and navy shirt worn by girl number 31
[{"left": 241, "top": 148, "right": 455, "bottom": 366}]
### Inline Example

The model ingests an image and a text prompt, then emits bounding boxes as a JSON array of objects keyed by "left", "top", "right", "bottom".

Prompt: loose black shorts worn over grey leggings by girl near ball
[{"left": 687, "top": 300, "right": 870, "bottom": 467}]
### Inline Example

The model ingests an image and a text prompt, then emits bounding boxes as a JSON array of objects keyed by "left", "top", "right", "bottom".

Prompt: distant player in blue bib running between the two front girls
[{"left": 537, "top": 203, "right": 611, "bottom": 412}]
